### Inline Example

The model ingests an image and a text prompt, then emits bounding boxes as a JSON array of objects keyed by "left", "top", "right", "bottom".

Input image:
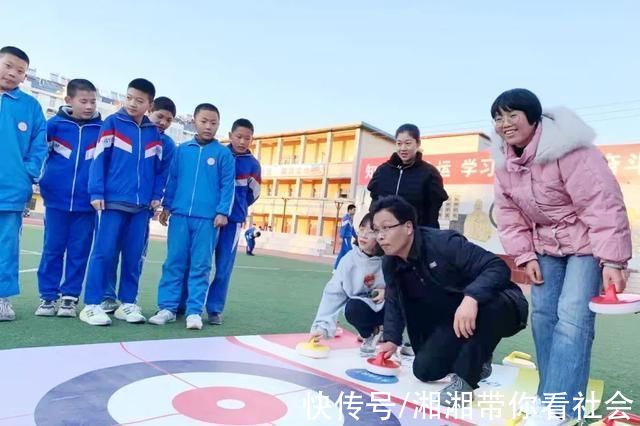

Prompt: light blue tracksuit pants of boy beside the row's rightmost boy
[{"left": 158, "top": 214, "right": 218, "bottom": 315}]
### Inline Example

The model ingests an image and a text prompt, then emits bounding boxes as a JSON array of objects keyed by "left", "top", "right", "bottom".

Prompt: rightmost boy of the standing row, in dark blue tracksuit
[{"left": 207, "top": 118, "right": 262, "bottom": 325}]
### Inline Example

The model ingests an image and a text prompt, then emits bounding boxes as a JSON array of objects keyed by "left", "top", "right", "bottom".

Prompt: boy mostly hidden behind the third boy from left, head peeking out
[{"left": 100, "top": 96, "right": 176, "bottom": 313}]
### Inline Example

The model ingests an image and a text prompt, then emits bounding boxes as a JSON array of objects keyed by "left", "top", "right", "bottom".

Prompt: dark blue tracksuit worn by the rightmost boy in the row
[{"left": 207, "top": 144, "right": 262, "bottom": 314}]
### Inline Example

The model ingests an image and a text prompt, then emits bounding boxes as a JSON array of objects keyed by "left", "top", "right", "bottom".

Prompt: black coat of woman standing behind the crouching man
[{"left": 367, "top": 152, "right": 449, "bottom": 228}]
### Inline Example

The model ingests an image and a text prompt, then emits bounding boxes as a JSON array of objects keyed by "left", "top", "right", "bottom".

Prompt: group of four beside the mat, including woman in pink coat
[{"left": 310, "top": 89, "right": 632, "bottom": 426}]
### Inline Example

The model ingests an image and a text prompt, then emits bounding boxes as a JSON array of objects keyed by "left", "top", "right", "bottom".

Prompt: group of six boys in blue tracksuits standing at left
[{"left": 0, "top": 46, "right": 261, "bottom": 329}]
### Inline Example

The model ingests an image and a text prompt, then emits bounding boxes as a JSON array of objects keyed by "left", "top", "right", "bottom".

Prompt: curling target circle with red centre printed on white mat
[{"left": 34, "top": 360, "right": 400, "bottom": 425}]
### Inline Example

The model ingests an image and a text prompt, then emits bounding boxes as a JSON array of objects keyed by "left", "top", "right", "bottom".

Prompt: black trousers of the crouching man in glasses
[{"left": 405, "top": 294, "right": 521, "bottom": 389}]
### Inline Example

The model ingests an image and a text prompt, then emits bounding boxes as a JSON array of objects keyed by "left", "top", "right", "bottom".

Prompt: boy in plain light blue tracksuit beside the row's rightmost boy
[{"left": 149, "top": 104, "right": 235, "bottom": 330}]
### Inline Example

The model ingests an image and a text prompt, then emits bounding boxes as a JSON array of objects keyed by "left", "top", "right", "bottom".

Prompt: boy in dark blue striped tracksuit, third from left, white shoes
[{"left": 80, "top": 78, "right": 164, "bottom": 325}]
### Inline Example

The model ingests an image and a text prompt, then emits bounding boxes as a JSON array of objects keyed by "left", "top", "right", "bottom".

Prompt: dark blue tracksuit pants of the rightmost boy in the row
[{"left": 207, "top": 222, "right": 242, "bottom": 314}]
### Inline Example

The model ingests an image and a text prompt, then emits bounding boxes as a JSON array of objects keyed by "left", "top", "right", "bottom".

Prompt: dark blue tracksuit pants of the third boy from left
[{"left": 84, "top": 210, "right": 149, "bottom": 305}]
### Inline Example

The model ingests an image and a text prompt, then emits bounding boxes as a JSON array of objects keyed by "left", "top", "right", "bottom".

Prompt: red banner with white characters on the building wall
[{"left": 358, "top": 144, "right": 640, "bottom": 185}]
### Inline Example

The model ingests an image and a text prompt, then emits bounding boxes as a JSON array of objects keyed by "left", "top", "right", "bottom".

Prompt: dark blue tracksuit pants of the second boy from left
[{"left": 38, "top": 208, "right": 96, "bottom": 301}]
